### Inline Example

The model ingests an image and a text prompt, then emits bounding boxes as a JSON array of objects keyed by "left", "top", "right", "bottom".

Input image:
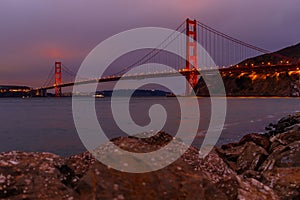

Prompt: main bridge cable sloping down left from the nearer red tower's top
[{"left": 112, "top": 21, "right": 185, "bottom": 76}]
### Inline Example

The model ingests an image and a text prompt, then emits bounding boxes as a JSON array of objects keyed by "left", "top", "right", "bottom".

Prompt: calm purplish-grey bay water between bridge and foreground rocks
[{"left": 0, "top": 97, "right": 300, "bottom": 156}]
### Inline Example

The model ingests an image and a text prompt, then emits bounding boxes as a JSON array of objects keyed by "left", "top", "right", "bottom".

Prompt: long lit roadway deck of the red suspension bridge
[{"left": 35, "top": 63, "right": 300, "bottom": 91}]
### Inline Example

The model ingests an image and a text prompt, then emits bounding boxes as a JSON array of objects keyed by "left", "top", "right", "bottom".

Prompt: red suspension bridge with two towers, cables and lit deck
[{"left": 34, "top": 19, "right": 299, "bottom": 97}]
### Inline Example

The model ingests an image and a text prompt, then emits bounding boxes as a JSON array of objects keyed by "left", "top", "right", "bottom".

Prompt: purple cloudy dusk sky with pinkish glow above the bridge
[{"left": 0, "top": 0, "right": 300, "bottom": 87}]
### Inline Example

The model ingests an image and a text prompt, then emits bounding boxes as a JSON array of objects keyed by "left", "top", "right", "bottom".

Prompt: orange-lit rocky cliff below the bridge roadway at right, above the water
[{"left": 195, "top": 70, "right": 300, "bottom": 97}]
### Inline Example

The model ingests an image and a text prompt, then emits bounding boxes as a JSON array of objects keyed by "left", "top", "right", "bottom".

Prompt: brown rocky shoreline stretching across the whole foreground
[{"left": 0, "top": 113, "right": 300, "bottom": 200}]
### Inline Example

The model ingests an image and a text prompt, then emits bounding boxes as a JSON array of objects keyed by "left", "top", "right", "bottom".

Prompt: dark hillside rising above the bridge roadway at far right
[{"left": 239, "top": 43, "right": 300, "bottom": 66}]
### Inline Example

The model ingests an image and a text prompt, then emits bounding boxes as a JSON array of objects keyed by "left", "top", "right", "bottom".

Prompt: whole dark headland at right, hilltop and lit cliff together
[{"left": 195, "top": 43, "right": 300, "bottom": 97}]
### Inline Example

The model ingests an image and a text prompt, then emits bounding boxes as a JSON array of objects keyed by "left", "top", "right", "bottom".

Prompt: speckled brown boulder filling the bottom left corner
[{"left": 0, "top": 152, "right": 78, "bottom": 199}]
